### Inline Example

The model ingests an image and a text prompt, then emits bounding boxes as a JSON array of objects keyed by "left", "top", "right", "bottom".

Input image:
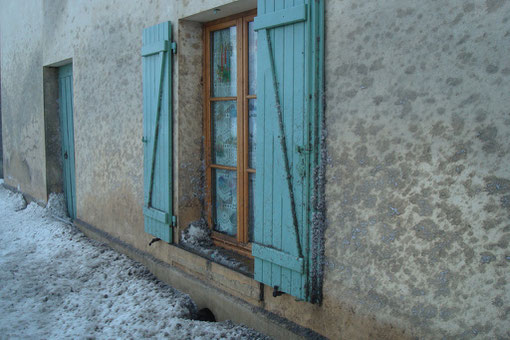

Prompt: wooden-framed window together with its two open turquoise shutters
[{"left": 142, "top": 0, "right": 326, "bottom": 303}]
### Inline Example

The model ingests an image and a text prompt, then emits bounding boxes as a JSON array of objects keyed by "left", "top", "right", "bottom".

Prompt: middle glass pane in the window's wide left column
[{"left": 211, "top": 100, "right": 237, "bottom": 166}]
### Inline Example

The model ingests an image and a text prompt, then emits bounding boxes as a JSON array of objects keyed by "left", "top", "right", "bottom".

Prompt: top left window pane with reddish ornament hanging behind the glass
[{"left": 211, "top": 26, "right": 237, "bottom": 97}]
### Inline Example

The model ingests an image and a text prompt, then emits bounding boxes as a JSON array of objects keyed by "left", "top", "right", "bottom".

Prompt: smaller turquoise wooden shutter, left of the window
[{"left": 142, "top": 22, "right": 172, "bottom": 242}]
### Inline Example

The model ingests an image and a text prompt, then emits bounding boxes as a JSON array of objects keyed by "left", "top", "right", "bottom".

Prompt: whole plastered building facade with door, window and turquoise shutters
[{"left": 0, "top": 0, "right": 510, "bottom": 339}]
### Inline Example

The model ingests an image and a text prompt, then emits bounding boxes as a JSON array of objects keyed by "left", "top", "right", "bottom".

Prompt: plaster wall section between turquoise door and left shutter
[{"left": 54, "top": 1, "right": 169, "bottom": 243}]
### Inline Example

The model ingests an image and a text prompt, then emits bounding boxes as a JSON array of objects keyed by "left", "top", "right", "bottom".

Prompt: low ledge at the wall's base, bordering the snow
[{"left": 74, "top": 219, "right": 326, "bottom": 339}]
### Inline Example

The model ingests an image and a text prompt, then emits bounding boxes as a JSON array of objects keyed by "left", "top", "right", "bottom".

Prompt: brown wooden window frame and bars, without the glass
[{"left": 203, "top": 9, "right": 257, "bottom": 258}]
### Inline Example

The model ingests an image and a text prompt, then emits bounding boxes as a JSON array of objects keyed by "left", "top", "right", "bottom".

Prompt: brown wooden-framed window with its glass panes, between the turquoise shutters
[{"left": 204, "top": 11, "right": 257, "bottom": 256}]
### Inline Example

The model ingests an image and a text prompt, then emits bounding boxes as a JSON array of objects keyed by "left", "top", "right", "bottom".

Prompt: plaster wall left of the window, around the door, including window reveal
[{"left": 1, "top": 0, "right": 254, "bottom": 249}]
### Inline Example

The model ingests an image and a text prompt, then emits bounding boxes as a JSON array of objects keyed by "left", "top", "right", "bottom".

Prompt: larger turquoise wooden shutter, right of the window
[{"left": 252, "top": 0, "right": 322, "bottom": 301}]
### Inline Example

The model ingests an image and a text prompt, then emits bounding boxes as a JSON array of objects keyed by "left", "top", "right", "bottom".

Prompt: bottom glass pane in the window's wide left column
[{"left": 212, "top": 169, "right": 237, "bottom": 236}]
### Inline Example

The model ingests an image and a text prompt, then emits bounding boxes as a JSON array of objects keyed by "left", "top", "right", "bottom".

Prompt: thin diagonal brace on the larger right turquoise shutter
[{"left": 264, "top": 29, "right": 303, "bottom": 258}]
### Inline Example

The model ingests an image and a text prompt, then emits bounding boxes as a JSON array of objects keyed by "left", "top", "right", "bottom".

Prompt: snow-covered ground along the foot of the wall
[{"left": 0, "top": 180, "right": 266, "bottom": 339}]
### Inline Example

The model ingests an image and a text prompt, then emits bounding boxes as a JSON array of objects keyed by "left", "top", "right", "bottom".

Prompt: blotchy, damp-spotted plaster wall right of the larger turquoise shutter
[{"left": 324, "top": 0, "right": 510, "bottom": 339}]
